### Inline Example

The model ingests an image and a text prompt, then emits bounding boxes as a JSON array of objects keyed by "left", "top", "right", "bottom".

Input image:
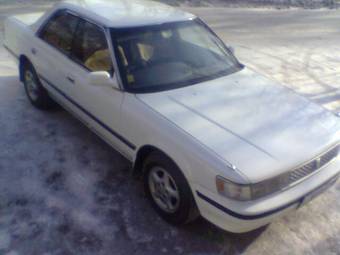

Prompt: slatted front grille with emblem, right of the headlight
[{"left": 289, "top": 146, "right": 339, "bottom": 184}]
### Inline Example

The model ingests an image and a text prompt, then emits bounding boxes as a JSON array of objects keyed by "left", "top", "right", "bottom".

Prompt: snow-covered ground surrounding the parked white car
[{"left": 0, "top": 2, "right": 340, "bottom": 255}]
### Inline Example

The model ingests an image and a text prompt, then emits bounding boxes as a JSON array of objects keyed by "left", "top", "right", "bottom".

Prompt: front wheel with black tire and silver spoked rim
[{"left": 143, "top": 151, "right": 199, "bottom": 225}]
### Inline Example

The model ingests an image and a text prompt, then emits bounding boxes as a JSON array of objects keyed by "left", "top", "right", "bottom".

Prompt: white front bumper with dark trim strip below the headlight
[{"left": 195, "top": 156, "right": 340, "bottom": 233}]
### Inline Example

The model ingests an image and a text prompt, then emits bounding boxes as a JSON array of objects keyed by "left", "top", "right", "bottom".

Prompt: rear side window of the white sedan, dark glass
[{"left": 40, "top": 12, "right": 79, "bottom": 54}]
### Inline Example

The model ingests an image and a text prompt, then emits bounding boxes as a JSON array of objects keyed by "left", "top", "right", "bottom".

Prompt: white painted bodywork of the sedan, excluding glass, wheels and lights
[{"left": 5, "top": 0, "right": 340, "bottom": 232}]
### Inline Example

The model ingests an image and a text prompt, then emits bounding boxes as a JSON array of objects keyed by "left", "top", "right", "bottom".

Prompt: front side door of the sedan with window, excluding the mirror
[{"left": 64, "top": 20, "right": 134, "bottom": 158}]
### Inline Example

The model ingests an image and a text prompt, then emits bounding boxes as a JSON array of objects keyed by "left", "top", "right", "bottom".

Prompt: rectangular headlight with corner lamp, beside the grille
[{"left": 216, "top": 173, "right": 289, "bottom": 201}]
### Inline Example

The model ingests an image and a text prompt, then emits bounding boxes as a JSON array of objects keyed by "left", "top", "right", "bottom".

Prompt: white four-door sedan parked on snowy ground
[{"left": 5, "top": 0, "right": 340, "bottom": 232}]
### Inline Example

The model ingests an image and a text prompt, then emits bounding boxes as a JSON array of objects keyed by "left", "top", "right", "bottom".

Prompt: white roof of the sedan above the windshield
[{"left": 57, "top": 0, "right": 195, "bottom": 28}]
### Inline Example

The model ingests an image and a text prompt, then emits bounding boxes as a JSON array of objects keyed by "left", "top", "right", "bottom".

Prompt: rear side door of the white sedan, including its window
[{"left": 31, "top": 11, "right": 80, "bottom": 103}]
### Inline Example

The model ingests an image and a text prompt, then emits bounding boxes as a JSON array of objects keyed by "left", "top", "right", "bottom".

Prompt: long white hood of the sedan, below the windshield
[{"left": 137, "top": 68, "right": 340, "bottom": 183}]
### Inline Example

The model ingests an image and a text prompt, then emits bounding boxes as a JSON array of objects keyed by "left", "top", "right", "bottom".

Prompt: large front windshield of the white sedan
[{"left": 112, "top": 20, "right": 241, "bottom": 93}]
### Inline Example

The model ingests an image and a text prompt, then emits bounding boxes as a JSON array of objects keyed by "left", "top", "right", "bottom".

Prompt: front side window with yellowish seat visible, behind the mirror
[{"left": 72, "top": 21, "right": 113, "bottom": 72}]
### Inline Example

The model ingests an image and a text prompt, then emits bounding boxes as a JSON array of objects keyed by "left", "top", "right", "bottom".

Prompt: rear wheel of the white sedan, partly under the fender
[{"left": 23, "top": 62, "right": 55, "bottom": 110}]
